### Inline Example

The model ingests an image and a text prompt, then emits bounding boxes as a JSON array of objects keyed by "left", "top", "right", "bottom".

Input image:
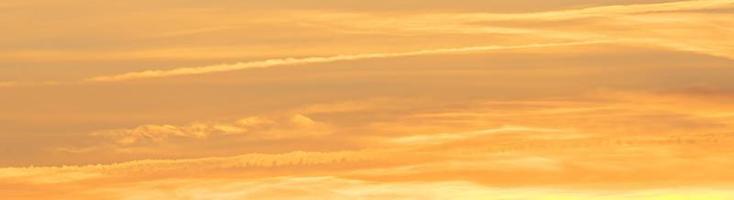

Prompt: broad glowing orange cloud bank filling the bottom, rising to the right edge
[{"left": 0, "top": 91, "right": 734, "bottom": 199}]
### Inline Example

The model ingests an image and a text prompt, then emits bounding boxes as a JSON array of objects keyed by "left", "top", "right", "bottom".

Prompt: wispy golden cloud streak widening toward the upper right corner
[{"left": 304, "top": 0, "right": 734, "bottom": 59}]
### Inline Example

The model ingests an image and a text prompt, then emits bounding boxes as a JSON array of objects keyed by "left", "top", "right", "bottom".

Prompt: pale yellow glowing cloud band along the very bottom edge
[{"left": 33, "top": 176, "right": 734, "bottom": 200}]
